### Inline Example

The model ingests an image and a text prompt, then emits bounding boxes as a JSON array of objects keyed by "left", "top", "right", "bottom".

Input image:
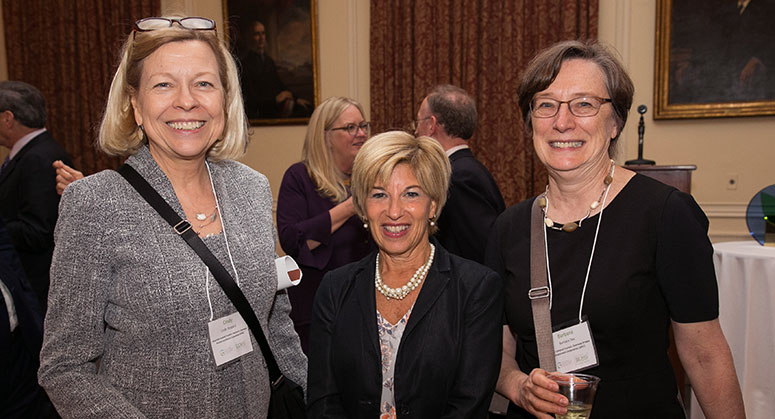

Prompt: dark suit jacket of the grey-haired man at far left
[{"left": 0, "top": 131, "right": 72, "bottom": 306}]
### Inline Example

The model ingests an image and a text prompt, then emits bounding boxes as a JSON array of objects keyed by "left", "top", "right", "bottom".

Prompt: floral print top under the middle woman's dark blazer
[{"left": 377, "top": 306, "right": 414, "bottom": 419}]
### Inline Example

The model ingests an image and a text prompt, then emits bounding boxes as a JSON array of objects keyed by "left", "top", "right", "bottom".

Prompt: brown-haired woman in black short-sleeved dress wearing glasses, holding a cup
[{"left": 487, "top": 41, "right": 744, "bottom": 419}]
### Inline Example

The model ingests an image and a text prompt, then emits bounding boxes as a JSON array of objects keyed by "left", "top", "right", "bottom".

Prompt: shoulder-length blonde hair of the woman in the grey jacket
[{"left": 97, "top": 19, "right": 249, "bottom": 161}]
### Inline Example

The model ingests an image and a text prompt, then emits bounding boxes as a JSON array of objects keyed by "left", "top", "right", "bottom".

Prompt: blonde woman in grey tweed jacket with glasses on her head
[{"left": 39, "top": 17, "right": 306, "bottom": 418}]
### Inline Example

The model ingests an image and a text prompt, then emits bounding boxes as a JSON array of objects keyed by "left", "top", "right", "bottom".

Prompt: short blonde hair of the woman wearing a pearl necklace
[{"left": 352, "top": 131, "right": 452, "bottom": 234}]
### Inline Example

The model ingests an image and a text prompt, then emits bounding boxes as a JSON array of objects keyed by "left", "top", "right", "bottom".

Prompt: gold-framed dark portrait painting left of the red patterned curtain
[{"left": 223, "top": 0, "right": 319, "bottom": 125}]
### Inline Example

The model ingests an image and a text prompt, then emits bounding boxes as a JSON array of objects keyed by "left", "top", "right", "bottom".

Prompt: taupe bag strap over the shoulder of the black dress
[{"left": 527, "top": 196, "right": 557, "bottom": 372}]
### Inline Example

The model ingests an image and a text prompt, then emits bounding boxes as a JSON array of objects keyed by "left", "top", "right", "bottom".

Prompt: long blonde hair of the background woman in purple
[{"left": 301, "top": 96, "right": 364, "bottom": 203}]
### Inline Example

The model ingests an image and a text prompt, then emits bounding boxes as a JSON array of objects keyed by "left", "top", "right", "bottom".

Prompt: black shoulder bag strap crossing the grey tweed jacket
[{"left": 118, "top": 164, "right": 290, "bottom": 387}]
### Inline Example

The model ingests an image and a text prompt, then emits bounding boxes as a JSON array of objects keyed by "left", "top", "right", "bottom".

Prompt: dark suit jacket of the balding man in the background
[{"left": 436, "top": 148, "right": 506, "bottom": 263}]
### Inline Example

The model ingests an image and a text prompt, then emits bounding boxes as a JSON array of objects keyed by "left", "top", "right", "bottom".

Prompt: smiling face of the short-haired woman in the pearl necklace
[{"left": 366, "top": 163, "right": 436, "bottom": 262}]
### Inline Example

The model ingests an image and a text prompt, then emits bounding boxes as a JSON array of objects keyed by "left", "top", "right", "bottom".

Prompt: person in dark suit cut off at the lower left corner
[{"left": 0, "top": 218, "right": 56, "bottom": 418}]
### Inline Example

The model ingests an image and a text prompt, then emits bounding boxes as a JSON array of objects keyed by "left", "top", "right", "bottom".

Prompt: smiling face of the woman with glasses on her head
[{"left": 131, "top": 41, "right": 225, "bottom": 167}]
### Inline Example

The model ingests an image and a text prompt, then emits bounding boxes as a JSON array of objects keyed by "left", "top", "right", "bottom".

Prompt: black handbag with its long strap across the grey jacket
[{"left": 118, "top": 164, "right": 306, "bottom": 419}]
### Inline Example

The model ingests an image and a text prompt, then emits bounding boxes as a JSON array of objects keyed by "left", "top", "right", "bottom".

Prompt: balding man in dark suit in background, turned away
[{"left": 414, "top": 85, "right": 506, "bottom": 263}]
